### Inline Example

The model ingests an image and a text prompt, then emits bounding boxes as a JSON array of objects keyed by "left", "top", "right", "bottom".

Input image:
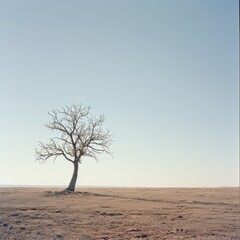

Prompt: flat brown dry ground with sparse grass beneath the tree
[{"left": 0, "top": 188, "right": 240, "bottom": 240}]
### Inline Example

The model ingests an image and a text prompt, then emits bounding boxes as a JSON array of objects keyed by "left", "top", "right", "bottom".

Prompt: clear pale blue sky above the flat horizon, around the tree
[{"left": 0, "top": 0, "right": 239, "bottom": 187}]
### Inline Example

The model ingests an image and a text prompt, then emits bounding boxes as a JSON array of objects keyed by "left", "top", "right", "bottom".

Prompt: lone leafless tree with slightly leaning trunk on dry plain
[{"left": 36, "top": 104, "right": 112, "bottom": 192}]
